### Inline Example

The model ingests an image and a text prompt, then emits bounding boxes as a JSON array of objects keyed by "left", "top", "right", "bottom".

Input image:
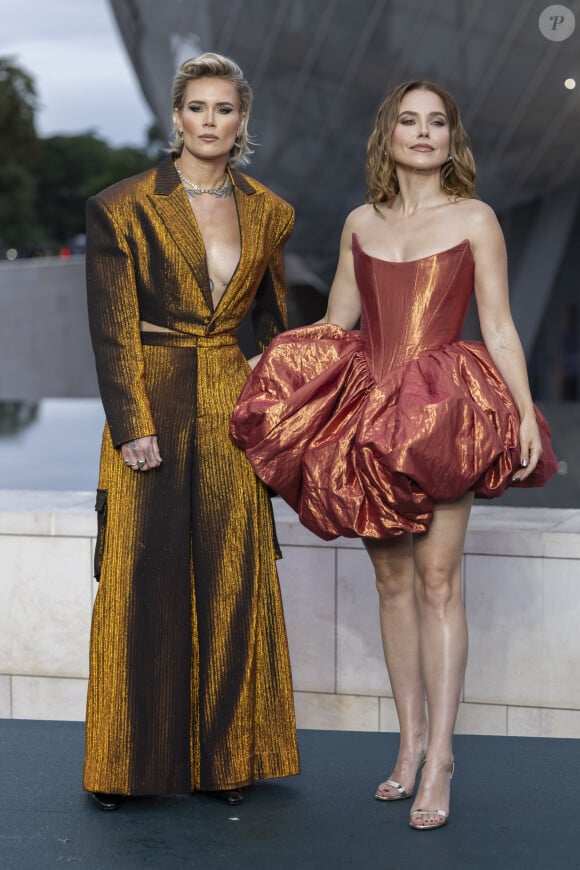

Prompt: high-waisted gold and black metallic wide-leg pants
[{"left": 84, "top": 333, "right": 299, "bottom": 795}]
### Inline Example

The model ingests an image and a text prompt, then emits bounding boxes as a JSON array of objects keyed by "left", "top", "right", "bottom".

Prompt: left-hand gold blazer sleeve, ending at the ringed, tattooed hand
[{"left": 86, "top": 197, "right": 156, "bottom": 447}]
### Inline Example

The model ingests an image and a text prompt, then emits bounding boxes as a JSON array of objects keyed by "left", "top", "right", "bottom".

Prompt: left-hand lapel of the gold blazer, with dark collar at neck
[{"left": 149, "top": 157, "right": 213, "bottom": 311}]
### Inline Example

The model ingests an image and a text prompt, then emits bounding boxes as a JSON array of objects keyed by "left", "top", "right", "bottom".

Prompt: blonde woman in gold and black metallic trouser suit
[{"left": 84, "top": 53, "right": 299, "bottom": 809}]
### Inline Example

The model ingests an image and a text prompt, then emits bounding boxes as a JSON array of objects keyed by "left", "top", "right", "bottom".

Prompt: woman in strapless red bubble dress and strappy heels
[{"left": 231, "top": 82, "right": 556, "bottom": 830}]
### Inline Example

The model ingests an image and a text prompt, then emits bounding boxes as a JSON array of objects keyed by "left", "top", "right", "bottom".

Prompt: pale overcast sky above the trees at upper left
[{"left": 0, "top": 0, "right": 152, "bottom": 145}]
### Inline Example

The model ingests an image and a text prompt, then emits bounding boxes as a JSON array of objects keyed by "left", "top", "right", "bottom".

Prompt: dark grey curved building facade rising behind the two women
[{"left": 111, "top": 0, "right": 580, "bottom": 372}]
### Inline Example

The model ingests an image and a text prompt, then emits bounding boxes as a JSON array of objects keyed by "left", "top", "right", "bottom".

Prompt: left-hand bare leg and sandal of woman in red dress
[{"left": 364, "top": 535, "right": 427, "bottom": 800}]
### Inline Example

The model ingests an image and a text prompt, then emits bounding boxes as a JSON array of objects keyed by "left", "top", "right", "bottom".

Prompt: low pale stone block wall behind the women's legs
[{"left": 0, "top": 491, "right": 580, "bottom": 737}]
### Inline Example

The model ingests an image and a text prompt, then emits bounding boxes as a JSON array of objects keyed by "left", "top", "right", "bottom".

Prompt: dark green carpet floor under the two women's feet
[{"left": 0, "top": 719, "right": 580, "bottom": 870}]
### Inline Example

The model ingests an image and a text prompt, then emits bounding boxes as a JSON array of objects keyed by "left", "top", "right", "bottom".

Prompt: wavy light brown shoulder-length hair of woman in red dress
[{"left": 365, "top": 81, "right": 476, "bottom": 207}]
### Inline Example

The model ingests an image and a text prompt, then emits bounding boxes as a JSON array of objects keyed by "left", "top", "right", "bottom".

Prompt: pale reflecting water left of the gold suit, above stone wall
[{"left": 0, "top": 399, "right": 105, "bottom": 491}]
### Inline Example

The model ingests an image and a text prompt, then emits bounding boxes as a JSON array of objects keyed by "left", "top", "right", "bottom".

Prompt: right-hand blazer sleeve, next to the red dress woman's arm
[{"left": 252, "top": 204, "right": 294, "bottom": 352}]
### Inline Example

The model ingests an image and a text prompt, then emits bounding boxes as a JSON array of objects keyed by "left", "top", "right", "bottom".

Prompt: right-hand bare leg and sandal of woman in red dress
[{"left": 413, "top": 493, "right": 473, "bottom": 827}]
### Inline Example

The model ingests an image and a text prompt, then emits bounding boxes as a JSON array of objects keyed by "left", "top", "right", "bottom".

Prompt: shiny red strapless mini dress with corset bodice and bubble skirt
[{"left": 230, "top": 235, "right": 557, "bottom": 540}]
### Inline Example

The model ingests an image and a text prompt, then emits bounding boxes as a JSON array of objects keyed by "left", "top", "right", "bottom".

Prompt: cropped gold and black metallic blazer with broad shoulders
[{"left": 87, "top": 157, "right": 294, "bottom": 447}]
